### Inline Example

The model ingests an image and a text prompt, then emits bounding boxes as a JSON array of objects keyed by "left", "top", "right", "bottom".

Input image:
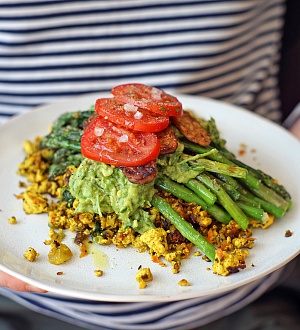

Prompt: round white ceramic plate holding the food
[{"left": 0, "top": 94, "right": 300, "bottom": 302}]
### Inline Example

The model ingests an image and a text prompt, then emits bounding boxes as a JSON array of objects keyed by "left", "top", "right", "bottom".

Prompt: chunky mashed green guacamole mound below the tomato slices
[{"left": 69, "top": 159, "right": 156, "bottom": 233}]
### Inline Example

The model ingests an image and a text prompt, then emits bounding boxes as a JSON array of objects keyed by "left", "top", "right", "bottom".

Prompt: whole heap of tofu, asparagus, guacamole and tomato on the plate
[{"left": 15, "top": 84, "right": 292, "bottom": 275}]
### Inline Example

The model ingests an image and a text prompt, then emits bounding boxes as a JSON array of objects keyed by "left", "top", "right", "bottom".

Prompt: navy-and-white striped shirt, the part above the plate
[{"left": 0, "top": 0, "right": 285, "bottom": 122}]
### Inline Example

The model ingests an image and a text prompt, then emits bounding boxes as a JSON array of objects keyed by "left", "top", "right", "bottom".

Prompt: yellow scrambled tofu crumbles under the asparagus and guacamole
[{"left": 17, "top": 135, "right": 258, "bottom": 278}]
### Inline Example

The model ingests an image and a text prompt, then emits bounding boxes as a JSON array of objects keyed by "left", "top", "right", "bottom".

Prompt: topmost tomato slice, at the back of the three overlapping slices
[{"left": 111, "top": 84, "right": 182, "bottom": 116}]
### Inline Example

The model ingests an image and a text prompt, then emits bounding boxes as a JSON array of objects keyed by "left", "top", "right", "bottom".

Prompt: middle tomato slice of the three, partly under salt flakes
[{"left": 95, "top": 98, "right": 169, "bottom": 132}]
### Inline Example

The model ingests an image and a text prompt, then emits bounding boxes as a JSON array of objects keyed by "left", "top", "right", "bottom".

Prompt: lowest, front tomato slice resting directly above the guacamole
[{"left": 81, "top": 116, "right": 160, "bottom": 166}]
